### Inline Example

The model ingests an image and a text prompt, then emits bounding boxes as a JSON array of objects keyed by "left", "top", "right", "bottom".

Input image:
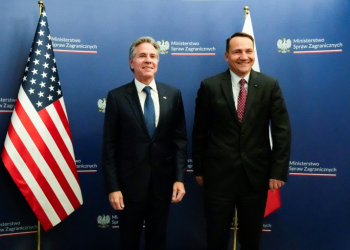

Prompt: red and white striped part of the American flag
[{"left": 2, "top": 86, "right": 83, "bottom": 230}]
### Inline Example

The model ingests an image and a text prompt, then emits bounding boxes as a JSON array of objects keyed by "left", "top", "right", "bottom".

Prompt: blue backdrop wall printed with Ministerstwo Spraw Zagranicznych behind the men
[{"left": 0, "top": 0, "right": 350, "bottom": 250}]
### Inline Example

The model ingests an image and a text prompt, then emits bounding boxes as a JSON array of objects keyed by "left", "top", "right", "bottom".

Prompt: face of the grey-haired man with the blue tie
[{"left": 129, "top": 43, "right": 158, "bottom": 85}]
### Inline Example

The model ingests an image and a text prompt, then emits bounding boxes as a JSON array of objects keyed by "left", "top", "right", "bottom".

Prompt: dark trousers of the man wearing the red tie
[{"left": 204, "top": 168, "right": 267, "bottom": 250}]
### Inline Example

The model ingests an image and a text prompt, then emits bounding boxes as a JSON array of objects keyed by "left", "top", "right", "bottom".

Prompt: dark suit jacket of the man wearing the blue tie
[{"left": 102, "top": 81, "right": 187, "bottom": 201}]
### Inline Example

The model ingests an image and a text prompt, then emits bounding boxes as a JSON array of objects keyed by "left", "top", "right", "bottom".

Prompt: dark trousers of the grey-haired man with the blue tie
[{"left": 116, "top": 191, "right": 170, "bottom": 250}]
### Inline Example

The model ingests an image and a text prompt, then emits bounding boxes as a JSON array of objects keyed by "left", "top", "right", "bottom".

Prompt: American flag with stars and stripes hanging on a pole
[{"left": 1, "top": 8, "right": 83, "bottom": 230}]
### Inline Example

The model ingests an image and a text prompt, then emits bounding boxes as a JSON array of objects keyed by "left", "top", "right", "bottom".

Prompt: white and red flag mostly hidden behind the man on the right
[{"left": 242, "top": 10, "right": 281, "bottom": 217}]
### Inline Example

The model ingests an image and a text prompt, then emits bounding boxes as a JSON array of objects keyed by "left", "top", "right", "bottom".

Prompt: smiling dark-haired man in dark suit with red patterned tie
[{"left": 193, "top": 32, "right": 291, "bottom": 250}]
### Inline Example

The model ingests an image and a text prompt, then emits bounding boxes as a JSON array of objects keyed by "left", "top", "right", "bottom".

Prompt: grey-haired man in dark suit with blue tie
[{"left": 102, "top": 37, "right": 187, "bottom": 250}]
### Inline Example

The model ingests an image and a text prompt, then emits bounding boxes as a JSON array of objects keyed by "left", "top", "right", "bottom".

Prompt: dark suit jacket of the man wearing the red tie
[{"left": 192, "top": 70, "right": 291, "bottom": 193}]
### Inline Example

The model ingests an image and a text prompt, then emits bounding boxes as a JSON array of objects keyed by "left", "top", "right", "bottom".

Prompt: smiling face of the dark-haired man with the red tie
[{"left": 225, "top": 36, "right": 255, "bottom": 78}]
